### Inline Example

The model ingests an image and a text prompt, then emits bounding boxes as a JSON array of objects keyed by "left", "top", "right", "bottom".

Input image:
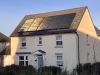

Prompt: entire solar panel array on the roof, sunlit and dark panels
[{"left": 20, "top": 13, "right": 75, "bottom": 31}]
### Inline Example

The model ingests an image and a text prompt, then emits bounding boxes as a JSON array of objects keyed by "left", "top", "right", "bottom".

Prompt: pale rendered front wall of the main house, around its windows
[{"left": 11, "top": 34, "right": 78, "bottom": 70}]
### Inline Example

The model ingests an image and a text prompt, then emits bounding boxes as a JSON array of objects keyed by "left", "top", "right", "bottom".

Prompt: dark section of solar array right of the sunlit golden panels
[{"left": 37, "top": 13, "right": 75, "bottom": 30}]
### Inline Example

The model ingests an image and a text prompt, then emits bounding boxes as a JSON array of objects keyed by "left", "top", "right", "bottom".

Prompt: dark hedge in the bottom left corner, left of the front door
[{"left": 0, "top": 65, "right": 36, "bottom": 75}]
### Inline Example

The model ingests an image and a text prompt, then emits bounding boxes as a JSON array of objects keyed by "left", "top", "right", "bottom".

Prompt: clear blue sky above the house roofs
[{"left": 0, "top": 0, "right": 100, "bottom": 36}]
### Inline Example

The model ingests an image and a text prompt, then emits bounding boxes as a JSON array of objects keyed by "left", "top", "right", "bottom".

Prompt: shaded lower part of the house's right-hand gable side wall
[{"left": 78, "top": 32, "right": 100, "bottom": 64}]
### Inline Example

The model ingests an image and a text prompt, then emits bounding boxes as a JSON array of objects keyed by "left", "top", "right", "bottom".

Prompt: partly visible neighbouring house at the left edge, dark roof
[{"left": 0, "top": 32, "right": 10, "bottom": 66}]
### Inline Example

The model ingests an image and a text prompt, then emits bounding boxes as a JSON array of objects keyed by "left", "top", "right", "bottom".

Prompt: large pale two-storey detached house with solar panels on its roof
[{"left": 4, "top": 7, "right": 100, "bottom": 72}]
